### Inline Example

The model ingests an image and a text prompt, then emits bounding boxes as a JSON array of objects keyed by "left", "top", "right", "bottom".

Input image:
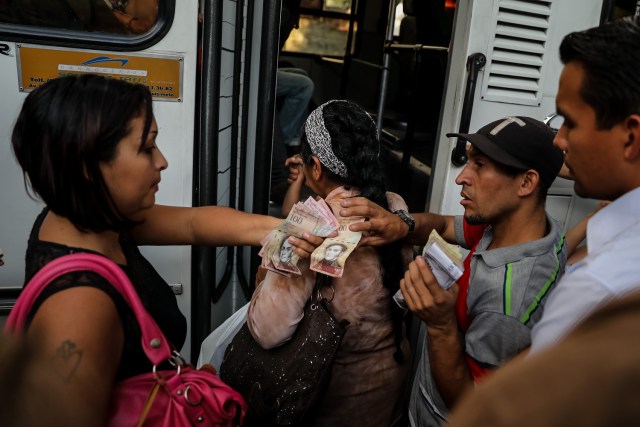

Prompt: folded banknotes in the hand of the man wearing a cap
[{"left": 393, "top": 230, "right": 464, "bottom": 308}]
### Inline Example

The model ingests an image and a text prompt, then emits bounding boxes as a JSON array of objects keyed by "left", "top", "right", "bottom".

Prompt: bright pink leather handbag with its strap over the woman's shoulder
[{"left": 4, "top": 254, "right": 247, "bottom": 427}]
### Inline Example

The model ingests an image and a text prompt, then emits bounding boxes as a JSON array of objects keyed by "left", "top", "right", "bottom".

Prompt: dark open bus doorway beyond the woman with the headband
[{"left": 274, "top": 0, "right": 456, "bottom": 210}]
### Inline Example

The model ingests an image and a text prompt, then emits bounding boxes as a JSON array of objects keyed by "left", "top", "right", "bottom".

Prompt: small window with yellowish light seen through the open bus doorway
[{"left": 284, "top": 0, "right": 357, "bottom": 57}]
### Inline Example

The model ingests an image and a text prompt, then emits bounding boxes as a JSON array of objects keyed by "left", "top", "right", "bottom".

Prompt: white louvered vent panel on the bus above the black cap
[{"left": 482, "top": 0, "right": 552, "bottom": 105}]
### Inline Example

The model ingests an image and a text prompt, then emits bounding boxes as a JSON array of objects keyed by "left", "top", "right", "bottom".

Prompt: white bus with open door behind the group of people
[{"left": 0, "top": 0, "right": 624, "bottom": 361}]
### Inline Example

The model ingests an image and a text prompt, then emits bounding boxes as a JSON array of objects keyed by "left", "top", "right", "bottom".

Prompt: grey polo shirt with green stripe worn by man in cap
[{"left": 409, "top": 214, "right": 567, "bottom": 427}]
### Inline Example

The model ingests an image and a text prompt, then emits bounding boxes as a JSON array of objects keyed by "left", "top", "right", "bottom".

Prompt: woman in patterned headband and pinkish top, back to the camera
[{"left": 248, "top": 101, "right": 412, "bottom": 427}]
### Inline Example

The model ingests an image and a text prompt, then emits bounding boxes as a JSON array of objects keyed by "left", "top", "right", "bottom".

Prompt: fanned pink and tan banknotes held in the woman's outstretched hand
[{"left": 259, "top": 197, "right": 364, "bottom": 277}]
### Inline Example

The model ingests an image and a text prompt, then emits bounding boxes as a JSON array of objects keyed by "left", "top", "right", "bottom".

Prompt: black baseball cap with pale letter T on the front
[{"left": 447, "top": 116, "right": 564, "bottom": 188}]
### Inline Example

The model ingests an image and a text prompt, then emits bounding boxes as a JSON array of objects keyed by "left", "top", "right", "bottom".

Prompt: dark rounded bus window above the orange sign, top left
[{"left": 0, "top": 0, "right": 175, "bottom": 50}]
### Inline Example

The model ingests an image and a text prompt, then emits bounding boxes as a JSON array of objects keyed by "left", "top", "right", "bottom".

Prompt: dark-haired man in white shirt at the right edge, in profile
[{"left": 531, "top": 18, "right": 640, "bottom": 352}]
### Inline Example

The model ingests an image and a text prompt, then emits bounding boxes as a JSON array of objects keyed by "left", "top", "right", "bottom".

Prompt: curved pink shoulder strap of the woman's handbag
[{"left": 4, "top": 253, "right": 171, "bottom": 365}]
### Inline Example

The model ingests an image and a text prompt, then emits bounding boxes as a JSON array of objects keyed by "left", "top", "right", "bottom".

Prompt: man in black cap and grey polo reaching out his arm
[{"left": 340, "top": 116, "right": 566, "bottom": 426}]
